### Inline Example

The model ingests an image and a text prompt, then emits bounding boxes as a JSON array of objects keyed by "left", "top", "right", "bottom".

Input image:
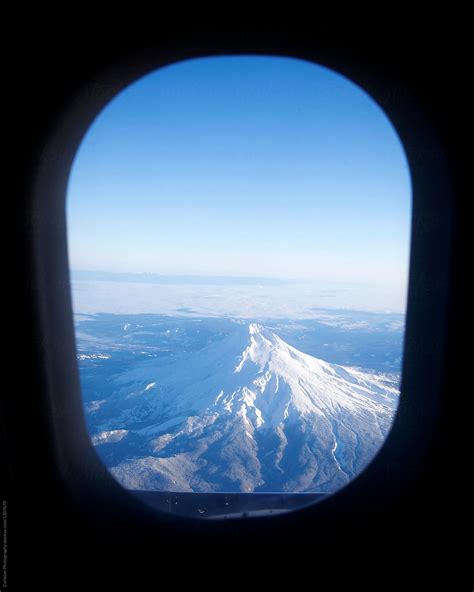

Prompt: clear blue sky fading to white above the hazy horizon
[{"left": 67, "top": 56, "right": 411, "bottom": 306}]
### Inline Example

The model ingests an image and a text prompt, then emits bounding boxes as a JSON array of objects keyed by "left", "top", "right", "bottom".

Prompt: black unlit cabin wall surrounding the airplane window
[{"left": 2, "top": 17, "right": 469, "bottom": 590}]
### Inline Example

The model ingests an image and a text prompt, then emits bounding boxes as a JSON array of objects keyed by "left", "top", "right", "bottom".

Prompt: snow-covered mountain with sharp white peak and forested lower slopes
[{"left": 89, "top": 323, "right": 398, "bottom": 493}]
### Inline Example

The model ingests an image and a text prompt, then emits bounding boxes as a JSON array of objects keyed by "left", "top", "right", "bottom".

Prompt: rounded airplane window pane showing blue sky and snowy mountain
[{"left": 67, "top": 56, "right": 411, "bottom": 518}]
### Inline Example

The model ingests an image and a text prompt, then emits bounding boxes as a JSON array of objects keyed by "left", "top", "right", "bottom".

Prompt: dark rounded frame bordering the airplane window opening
[{"left": 30, "top": 46, "right": 454, "bottom": 520}]
